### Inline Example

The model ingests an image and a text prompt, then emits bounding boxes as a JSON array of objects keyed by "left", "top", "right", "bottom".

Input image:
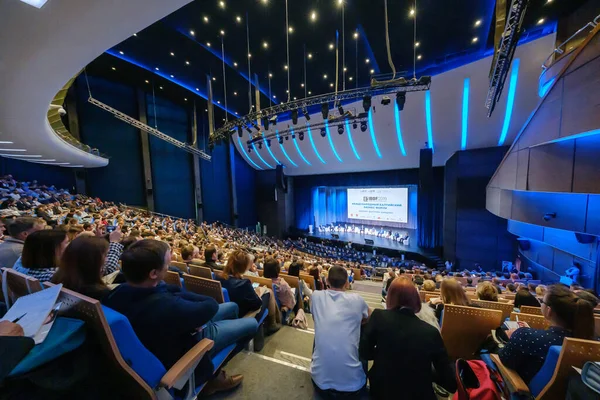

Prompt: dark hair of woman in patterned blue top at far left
[{"left": 21, "top": 229, "right": 69, "bottom": 269}]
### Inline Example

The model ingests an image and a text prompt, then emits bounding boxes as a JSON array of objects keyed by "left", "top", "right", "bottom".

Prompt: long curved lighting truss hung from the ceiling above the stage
[{"left": 209, "top": 76, "right": 431, "bottom": 144}]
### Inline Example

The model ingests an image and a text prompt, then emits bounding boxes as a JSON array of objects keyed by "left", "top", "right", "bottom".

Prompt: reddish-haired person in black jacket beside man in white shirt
[{"left": 360, "top": 278, "right": 456, "bottom": 400}]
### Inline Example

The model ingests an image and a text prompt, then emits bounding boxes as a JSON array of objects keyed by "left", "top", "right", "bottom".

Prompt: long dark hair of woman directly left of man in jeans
[{"left": 52, "top": 236, "right": 108, "bottom": 292}]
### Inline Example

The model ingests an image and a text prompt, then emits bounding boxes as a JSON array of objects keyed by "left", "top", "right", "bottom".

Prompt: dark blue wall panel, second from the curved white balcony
[{"left": 146, "top": 94, "right": 196, "bottom": 218}]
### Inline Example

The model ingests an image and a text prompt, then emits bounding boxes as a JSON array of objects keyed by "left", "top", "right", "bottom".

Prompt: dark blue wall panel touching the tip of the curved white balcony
[{"left": 77, "top": 77, "right": 146, "bottom": 206}]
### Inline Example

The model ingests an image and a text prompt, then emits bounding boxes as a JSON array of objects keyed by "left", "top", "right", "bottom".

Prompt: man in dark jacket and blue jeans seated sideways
[{"left": 103, "top": 239, "right": 258, "bottom": 393}]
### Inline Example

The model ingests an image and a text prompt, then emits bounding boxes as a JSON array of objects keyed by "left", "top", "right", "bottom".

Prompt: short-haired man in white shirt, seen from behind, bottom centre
[{"left": 312, "top": 266, "right": 370, "bottom": 397}]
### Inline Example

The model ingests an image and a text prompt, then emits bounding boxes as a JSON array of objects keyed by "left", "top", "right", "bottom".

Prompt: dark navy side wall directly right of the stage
[{"left": 444, "top": 146, "right": 516, "bottom": 270}]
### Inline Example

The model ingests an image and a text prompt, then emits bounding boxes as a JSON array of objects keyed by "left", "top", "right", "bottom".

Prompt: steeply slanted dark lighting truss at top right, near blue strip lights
[{"left": 485, "top": 0, "right": 529, "bottom": 117}]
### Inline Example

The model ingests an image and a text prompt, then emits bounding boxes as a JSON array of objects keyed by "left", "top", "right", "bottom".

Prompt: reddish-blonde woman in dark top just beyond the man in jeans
[{"left": 217, "top": 250, "right": 269, "bottom": 316}]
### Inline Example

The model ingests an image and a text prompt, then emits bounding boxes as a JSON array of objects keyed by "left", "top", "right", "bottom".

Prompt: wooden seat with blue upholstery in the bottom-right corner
[{"left": 491, "top": 338, "right": 600, "bottom": 400}]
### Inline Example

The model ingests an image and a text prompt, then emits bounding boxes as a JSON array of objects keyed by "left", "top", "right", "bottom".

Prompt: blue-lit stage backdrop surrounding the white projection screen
[{"left": 311, "top": 185, "right": 417, "bottom": 229}]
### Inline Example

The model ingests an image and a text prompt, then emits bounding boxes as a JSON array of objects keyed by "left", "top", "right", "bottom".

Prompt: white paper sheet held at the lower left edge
[{"left": 0, "top": 284, "right": 62, "bottom": 344}]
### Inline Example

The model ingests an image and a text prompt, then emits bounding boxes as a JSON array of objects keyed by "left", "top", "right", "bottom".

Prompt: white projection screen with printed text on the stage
[{"left": 348, "top": 187, "right": 408, "bottom": 223}]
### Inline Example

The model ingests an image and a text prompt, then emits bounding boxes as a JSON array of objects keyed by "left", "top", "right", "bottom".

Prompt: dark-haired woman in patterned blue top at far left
[{"left": 14, "top": 229, "right": 69, "bottom": 282}]
